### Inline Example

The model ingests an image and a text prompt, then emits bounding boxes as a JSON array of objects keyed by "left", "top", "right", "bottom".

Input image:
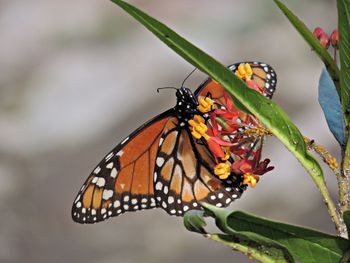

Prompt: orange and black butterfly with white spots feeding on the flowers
[{"left": 72, "top": 62, "right": 277, "bottom": 223}]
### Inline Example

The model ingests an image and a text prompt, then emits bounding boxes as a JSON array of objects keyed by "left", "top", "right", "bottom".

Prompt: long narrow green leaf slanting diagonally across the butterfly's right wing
[{"left": 112, "top": 0, "right": 325, "bottom": 194}]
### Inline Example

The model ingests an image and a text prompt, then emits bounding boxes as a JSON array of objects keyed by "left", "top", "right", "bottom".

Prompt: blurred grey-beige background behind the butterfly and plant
[{"left": 0, "top": 0, "right": 339, "bottom": 263}]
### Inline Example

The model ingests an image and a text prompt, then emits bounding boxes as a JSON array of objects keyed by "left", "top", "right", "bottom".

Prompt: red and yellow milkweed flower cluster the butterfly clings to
[{"left": 188, "top": 64, "right": 273, "bottom": 187}]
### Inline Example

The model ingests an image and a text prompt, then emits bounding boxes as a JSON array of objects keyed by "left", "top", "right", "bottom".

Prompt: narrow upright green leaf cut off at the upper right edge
[{"left": 337, "top": 0, "right": 350, "bottom": 122}]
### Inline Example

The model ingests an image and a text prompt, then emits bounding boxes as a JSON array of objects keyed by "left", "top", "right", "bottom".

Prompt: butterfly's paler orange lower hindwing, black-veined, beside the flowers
[{"left": 154, "top": 119, "right": 242, "bottom": 216}]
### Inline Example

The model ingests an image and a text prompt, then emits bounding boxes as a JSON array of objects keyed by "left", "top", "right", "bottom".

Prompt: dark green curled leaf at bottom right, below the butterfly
[{"left": 209, "top": 208, "right": 349, "bottom": 263}]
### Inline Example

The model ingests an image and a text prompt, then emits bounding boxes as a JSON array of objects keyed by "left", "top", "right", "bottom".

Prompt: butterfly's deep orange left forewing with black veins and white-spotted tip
[{"left": 72, "top": 110, "right": 176, "bottom": 223}]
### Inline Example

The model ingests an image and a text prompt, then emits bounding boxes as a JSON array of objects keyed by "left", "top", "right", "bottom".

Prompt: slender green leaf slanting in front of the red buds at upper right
[{"left": 273, "top": 0, "right": 343, "bottom": 96}]
